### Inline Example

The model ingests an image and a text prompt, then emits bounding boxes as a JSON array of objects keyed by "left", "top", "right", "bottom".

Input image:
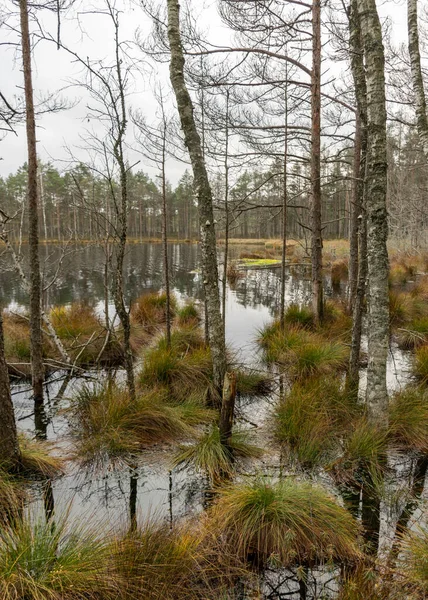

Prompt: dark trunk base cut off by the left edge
[{"left": 0, "top": 311, "right": 19, "bottom": 468}]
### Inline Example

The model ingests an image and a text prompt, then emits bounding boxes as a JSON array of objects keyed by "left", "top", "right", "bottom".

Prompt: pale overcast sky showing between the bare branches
[{"left": 0, "top": 0, "right": 406, "bottom": 184}]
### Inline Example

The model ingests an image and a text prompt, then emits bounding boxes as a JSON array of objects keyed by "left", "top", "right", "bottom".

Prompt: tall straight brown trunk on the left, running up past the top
[{"left": 19, "top": 0, "right": 44, "bottom": 406}]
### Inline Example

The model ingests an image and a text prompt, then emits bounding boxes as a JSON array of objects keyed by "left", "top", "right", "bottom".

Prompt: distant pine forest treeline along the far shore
[{"left": 0, "top": 124, "right": 428, "bottom": 248}]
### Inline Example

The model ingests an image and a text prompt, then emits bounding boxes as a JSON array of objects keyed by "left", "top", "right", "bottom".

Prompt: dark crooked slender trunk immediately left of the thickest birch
[{"left": 348, "top": 0, "right": 367, "bottom": 395}]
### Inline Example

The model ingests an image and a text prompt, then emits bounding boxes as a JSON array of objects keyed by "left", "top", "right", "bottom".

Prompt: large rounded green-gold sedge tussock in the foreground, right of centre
[{"left": 212, "top": 478, "right": 360, "bottom": 567}]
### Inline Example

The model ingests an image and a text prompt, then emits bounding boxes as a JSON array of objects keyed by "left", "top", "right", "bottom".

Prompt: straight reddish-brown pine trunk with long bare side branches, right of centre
[{"left": 311, "top": 0, "right": 324, "bottom": 322}]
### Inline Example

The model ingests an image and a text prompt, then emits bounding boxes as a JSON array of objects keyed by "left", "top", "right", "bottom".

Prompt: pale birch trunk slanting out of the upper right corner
[{"left": 407, "top": 0, "right": 428, "bottom": 159}]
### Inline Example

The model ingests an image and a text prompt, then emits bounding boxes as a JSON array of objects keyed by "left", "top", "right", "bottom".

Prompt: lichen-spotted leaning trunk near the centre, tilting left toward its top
[{"left": 167, "top": 0, "right": 226, "bottom": 395}]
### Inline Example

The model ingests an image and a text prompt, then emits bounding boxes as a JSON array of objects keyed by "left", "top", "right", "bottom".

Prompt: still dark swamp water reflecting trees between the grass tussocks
[{"left": 0, "top": 243, "right": 418, "bottom": 598}]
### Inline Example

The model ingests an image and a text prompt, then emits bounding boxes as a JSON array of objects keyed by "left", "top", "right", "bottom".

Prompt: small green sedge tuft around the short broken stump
[{"left": 174, "top": 426, "right": 263, "bottom": 485}]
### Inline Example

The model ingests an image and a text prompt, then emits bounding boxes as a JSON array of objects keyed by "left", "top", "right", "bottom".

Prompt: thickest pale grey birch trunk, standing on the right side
[{"left": 358, "top": 0, "right": 389, "bottom": 427}]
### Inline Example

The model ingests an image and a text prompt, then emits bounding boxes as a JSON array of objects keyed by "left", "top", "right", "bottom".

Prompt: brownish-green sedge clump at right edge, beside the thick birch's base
[{"left": 389, "top": 386, "right": 428, "bottom": 452}]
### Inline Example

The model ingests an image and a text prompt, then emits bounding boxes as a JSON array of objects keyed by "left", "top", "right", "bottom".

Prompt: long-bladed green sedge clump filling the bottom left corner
[{"left": 0, "top": 510, "right": 119, "bottom": 600}]
